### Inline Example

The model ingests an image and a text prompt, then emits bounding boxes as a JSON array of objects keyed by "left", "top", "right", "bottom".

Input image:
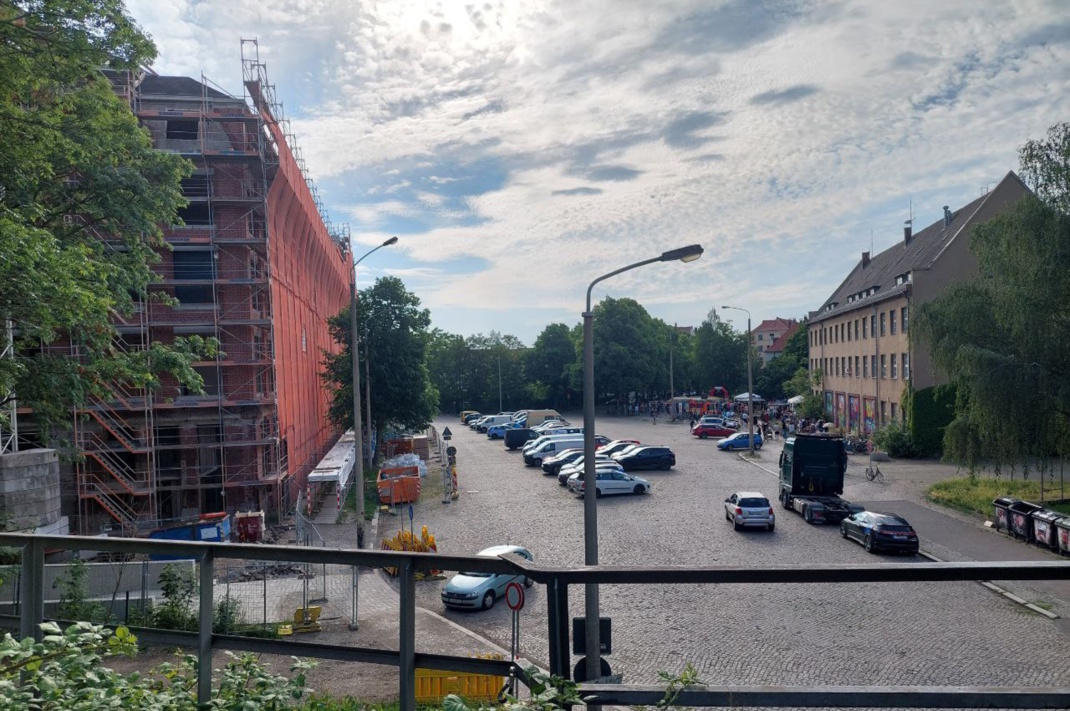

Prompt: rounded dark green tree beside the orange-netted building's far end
[{"left": 323, "top": 276, "right": 439, "bottom": 441}]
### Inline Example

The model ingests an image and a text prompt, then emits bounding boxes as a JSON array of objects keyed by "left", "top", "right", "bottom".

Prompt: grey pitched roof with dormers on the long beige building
[{"left": 813, "top": 170, "right": 1028, "bottom": 321}]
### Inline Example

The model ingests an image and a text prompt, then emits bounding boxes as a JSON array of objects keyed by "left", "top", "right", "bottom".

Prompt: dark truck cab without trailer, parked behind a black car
[{"left": 780, "top": 435, "right": 865, "bottom": 526}]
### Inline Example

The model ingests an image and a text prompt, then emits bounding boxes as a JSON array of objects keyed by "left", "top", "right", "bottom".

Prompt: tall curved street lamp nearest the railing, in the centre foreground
[{"left": 583, "top": 244, "right": 702, "bottom": 679}]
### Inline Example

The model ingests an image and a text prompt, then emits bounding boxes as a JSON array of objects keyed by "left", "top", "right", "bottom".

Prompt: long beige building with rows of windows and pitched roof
[{"left": 809, "top": 172, "right": 1029, "bottom": 432}]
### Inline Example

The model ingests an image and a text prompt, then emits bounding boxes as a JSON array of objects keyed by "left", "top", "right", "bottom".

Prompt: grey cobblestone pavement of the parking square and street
[{"left": 380, "top": 418, "right": 1070, "bottom": 685}]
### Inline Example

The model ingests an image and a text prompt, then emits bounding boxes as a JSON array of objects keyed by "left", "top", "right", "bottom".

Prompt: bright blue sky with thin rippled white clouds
[{"left": 127, "top": 0, "right": 1070, "bottom": 345}]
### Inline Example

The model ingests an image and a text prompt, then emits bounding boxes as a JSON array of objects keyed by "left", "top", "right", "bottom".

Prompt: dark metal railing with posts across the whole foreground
[{"left": 0, "top": 533, "right": 1070, "bottom": 711}]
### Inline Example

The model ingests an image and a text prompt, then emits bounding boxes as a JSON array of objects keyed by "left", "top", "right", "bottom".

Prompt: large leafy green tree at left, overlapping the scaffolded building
[{"left": 0, "top": 0, "right": 214, "bottom": 436}]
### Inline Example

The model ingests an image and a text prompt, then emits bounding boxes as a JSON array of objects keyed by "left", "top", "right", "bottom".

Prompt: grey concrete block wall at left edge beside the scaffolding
[{"left": 0, "top": 450, "right": 60, "bottom": 530}]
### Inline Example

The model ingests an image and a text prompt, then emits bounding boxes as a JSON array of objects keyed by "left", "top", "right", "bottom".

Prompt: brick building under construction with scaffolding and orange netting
[{"left": 64, "top": 41, "right": 353, "bottom": 534}]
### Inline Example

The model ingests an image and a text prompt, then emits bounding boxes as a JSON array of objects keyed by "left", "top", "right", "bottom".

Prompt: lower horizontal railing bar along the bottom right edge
[{"left": 579, "top": 684, "right": 1070, "bottom": 709}]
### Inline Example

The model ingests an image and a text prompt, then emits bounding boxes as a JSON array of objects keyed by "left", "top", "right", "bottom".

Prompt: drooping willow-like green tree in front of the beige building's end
[{"left": 910, "top": 196, "right": 1070, "bottom": 470}]
